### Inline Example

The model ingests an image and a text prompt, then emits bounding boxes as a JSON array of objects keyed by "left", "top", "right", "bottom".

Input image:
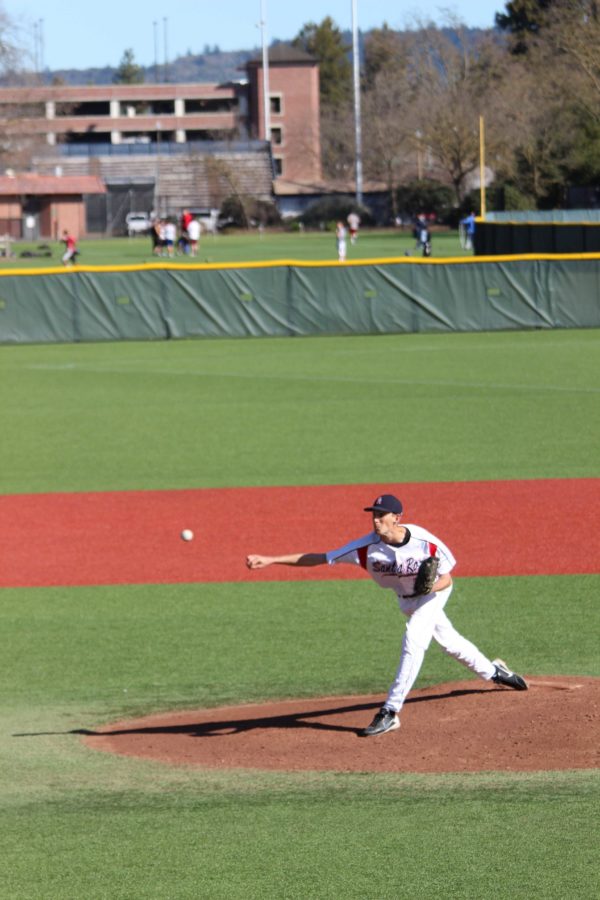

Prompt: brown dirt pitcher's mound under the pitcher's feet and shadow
[{"left": 85, "top": 677, "right": 600, "bottom": 772}]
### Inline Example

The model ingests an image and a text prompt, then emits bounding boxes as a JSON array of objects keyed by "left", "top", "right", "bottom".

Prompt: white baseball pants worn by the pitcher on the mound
[{"left": 385, "top": 585, "right": 496, "bottom": 712}]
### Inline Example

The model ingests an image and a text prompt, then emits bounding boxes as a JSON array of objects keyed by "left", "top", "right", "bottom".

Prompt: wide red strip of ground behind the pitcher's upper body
[{"left": 0, "top": 479, "right": 600, "bottom": 587}]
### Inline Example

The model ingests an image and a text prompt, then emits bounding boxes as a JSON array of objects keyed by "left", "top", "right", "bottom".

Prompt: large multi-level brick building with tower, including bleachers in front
[{"left": 0, "top": 45, "right": 321, "bottom": 233}]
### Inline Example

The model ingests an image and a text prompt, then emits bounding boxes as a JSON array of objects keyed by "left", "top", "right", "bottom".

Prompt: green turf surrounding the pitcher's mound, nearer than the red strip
[{"left": 0, "top": 576, "right": 600, "bottom": 900}]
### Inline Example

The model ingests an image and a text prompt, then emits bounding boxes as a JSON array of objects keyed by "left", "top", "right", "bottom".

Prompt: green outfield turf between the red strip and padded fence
[{"left": 0, "top": 331, "right": 600, "bottom": 493}]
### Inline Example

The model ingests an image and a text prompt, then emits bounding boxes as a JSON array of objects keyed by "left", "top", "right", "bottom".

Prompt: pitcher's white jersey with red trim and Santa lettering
[{"left": 326, "top": 525, "right": 456, "bottom": 597}]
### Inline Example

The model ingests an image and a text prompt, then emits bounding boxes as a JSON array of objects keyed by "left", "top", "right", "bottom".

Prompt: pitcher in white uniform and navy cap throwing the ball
[{"left": 246, "top": 494, "right": 527, "bottom": 737}]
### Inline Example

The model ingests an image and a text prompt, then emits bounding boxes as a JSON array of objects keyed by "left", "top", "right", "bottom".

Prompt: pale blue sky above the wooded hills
[{"left": 8, "top": 0, "right": 506, "bottom": 69}]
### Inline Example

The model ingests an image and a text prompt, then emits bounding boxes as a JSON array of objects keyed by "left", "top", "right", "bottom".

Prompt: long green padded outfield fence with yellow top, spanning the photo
[{"left": 0, "top": 254, "right": 600, "bottom": 344}]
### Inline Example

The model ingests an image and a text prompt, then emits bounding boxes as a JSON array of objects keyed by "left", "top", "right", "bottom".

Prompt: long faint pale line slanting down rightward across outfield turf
[{"left": 23, "top": 363, "right": 600, "bottom": 394}]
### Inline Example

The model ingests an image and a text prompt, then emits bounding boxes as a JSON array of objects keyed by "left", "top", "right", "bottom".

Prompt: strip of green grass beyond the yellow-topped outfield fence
[{"left": 0, "top": 229, "right": 473, "bottom": 271}]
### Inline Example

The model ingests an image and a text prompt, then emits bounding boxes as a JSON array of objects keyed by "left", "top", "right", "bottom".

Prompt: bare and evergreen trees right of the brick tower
[{"left": 293, "top": 0, "right": 600, "bottom": 209}]
